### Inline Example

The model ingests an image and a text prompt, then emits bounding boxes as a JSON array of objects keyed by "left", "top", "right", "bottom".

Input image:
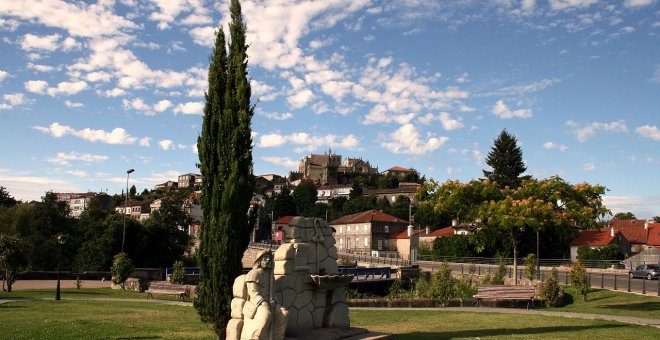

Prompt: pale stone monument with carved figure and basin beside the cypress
[{"left": 227, "top": 217, "right": 360, "bottom": 340}]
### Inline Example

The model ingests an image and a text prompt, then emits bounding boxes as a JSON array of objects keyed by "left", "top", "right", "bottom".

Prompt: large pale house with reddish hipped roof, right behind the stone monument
[{"left": 329, "top": 210, "right": 410, "bottom": 257}]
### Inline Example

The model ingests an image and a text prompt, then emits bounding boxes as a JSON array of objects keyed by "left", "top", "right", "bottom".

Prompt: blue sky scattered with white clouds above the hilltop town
[{"left": 0, "top": 0, "right": 660, "bottom": 218}]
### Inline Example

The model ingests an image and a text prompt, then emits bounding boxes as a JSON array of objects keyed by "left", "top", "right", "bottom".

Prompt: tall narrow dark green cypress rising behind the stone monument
[{"left": 194, "top": 0, "right": 254, "bottom": 339}]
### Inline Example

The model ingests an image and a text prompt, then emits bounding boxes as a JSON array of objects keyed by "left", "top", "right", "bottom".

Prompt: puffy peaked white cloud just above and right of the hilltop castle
[{"left": 381, "top": 124, "right": 449, "bottom": 155}]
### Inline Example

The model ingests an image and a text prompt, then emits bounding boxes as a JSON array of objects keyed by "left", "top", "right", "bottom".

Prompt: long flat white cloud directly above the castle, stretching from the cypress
[{"left": 256, "top": 132, "right": 360, "bottom": 153}]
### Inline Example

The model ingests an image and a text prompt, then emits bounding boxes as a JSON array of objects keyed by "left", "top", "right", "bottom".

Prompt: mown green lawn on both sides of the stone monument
[{"left": 0, "top": 289, "right": 660, "bottom": 339}]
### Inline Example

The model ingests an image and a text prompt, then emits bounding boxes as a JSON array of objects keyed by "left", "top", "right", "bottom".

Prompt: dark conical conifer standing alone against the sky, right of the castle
[{"left": 483, "top": 130, "right": 527, "bottom": 188}]
